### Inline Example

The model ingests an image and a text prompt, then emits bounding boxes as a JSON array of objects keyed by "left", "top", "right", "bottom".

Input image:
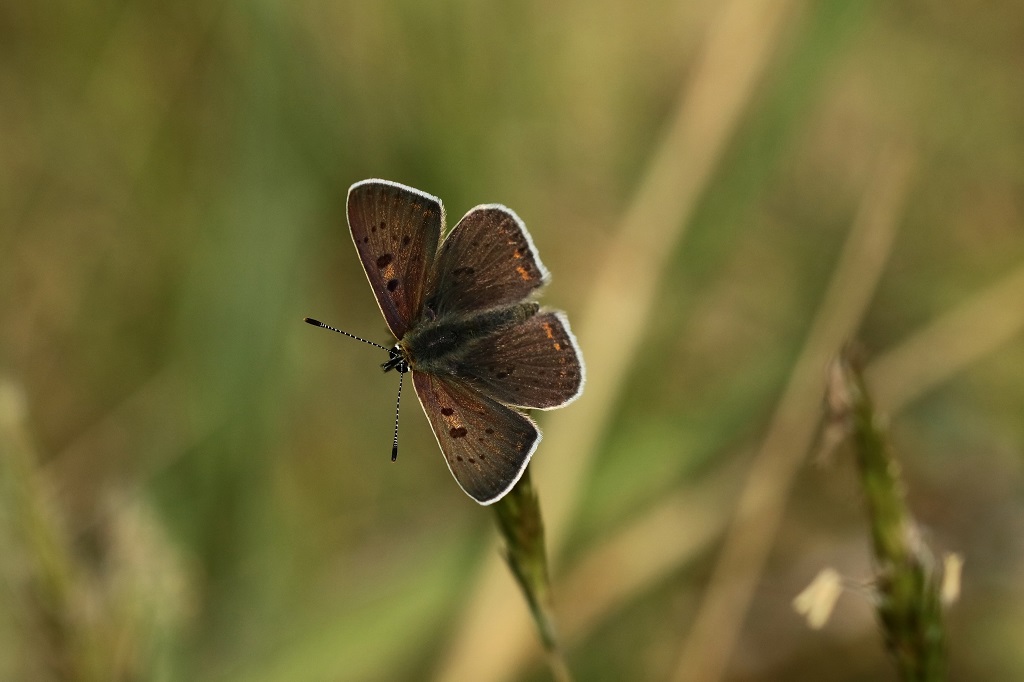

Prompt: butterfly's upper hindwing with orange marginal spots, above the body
[{"left": 427, "top": 204, "right": 549, "bottom": 314}]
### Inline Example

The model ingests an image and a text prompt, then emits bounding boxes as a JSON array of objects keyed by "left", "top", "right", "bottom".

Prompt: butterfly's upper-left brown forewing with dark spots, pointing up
[{"left": 348, "top": 180, "right": 444, "bottom": 339}]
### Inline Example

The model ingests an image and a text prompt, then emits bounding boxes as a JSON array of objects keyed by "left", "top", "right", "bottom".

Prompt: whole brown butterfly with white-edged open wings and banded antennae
[{"left": 306, "top": 179, "right": 586, "bottom": 505}]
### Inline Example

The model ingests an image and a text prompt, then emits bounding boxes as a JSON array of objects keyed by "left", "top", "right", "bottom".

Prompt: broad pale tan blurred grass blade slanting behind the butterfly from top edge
[{"left": 437, "top": 0, "right": 794, "bottom": 682}]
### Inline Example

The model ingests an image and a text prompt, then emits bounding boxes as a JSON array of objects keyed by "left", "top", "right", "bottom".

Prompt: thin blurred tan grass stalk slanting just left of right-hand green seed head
[{"left": 674, "top": 143, "right": 911, "bottom": 682}]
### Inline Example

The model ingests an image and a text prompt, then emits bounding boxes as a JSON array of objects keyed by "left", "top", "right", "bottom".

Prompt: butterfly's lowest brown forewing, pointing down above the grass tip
[{"left": 413, "top": 371, "right": 541, "bottom": 505}]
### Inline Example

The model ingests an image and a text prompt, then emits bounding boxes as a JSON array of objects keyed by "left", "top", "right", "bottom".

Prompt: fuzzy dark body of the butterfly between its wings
[{"left": 383, "top": 301, "right": 541, "bottom": 375}]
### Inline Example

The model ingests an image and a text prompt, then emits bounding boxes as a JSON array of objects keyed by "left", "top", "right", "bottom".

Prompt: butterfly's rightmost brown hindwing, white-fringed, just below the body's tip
[{"left": 457, "top": 310, "right": 586, "bottom": 410}]
